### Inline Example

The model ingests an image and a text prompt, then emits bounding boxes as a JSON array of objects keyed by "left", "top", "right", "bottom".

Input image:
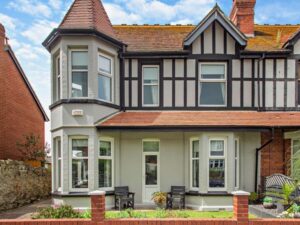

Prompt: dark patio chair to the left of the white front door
[{"left": 115, "top": 186, "right": 134, "bottom": 210}]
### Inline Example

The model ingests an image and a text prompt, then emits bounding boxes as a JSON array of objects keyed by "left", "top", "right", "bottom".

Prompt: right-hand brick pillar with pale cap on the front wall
[{"left": 232, "top": 191, "right": 250, "bottom": 225}]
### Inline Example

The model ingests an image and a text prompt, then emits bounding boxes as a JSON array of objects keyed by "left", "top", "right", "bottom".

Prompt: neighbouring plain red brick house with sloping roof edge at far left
[{"left": 0, "top": 23, "right": 48, "bottom": 160}]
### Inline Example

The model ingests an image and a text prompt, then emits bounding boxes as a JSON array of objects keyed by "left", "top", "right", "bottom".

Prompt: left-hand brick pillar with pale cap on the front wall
[{"left": 90, "top": 191, "right": 105, "bottom": 225}]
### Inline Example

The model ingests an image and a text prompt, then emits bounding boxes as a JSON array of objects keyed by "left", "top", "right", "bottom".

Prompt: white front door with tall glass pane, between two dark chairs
[{"left": 142, "top": 140, "right": 160, "bottom": 203}]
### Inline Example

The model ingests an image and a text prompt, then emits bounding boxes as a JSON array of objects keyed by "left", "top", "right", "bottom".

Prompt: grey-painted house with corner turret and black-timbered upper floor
[{"left": 43, "top": 0, "right": 300, "bottom": 210}]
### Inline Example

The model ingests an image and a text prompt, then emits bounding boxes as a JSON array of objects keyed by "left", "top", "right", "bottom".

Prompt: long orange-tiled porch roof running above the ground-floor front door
[{"left": 97, "top": 111, "right": 300, "bottom": 128}]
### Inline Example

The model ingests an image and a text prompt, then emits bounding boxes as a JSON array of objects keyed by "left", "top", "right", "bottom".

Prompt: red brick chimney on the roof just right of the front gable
[{"left": 230, "top": 0, "right": 256, "bottom": 37}]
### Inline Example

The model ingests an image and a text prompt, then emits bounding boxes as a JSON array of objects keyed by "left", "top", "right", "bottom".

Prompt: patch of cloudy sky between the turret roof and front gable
[{"left": 104, "top": 0, "right": 215, "bottom": 24}]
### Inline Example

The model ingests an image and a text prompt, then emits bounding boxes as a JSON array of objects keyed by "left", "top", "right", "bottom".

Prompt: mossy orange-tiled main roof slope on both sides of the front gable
[{"left": 113, "top": 25, "right": 300, "bottom": 52}]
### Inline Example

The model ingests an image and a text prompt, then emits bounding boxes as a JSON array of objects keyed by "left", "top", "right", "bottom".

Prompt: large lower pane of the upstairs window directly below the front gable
[{"left": 200, "top": 82, "right": 226, "bottom": 105}]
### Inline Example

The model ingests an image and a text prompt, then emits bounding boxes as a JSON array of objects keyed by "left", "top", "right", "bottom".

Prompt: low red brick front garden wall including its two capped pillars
[{"left": 0, "top": 191, "right": 300, "bottom": 225}]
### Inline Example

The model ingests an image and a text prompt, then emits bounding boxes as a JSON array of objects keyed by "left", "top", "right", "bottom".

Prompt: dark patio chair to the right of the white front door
[{"left": 167, "top": 186, "right": 185, "bottom": 209}]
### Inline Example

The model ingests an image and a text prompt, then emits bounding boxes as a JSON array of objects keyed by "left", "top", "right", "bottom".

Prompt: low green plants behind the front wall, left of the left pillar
[{"left": 32, "top": 205, "right": 81, "bottom": 219}]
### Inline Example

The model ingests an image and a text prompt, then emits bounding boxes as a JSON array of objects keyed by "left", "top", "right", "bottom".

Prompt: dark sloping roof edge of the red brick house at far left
[{"left": 5, "top": 45, "right": 49, "bottom": 122}]
